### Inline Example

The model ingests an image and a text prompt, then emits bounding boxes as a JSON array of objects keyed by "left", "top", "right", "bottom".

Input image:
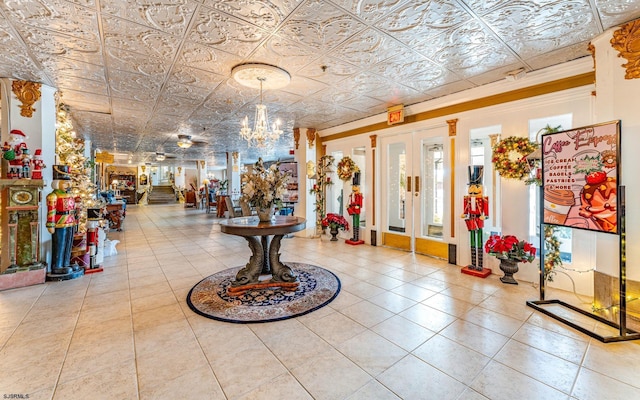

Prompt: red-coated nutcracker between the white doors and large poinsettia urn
[{"left": 462, "top": 165, "right": 491, "bottom": 276}]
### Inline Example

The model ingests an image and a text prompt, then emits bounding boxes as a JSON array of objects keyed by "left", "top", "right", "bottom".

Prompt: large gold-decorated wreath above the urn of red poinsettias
[{"left": 491, "top": 136, "right": 538, "bottom": 180}]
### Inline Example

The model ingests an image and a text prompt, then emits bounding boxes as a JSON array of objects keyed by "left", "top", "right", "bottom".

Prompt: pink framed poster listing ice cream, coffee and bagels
[{"left": 542, "top": 121, "right": 620, "bottom": 234}]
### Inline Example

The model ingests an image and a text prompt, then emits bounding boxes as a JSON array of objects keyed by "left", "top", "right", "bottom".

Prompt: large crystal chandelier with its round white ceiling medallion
[{"left": 231, "top": 63, "right": 291, "bottom": 148}]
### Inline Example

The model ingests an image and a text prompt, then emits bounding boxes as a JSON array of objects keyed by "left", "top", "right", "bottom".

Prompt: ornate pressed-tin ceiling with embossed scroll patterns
[{"left": 0, "top": 0, "right": 640, "bottom": 162}]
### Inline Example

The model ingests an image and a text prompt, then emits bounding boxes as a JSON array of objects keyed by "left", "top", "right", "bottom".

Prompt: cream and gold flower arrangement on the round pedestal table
[{"left": 241, "top": 158, "right": 289, "bottom": 210}]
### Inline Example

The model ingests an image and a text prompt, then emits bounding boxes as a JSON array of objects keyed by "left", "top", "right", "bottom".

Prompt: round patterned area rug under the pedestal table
[{"left": 187, "top": 262, "right": 340, "bottom": 324}]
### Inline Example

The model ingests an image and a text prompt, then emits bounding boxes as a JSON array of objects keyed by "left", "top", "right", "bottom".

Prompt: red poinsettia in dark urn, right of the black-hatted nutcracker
[{"left": 484, "top": 235, "right": 536, "bottom": 285}]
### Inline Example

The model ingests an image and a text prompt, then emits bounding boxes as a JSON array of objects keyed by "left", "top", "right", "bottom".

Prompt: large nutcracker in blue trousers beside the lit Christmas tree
[{"left": 46, "top": 165, "right": 83, "bottom": 280}]
